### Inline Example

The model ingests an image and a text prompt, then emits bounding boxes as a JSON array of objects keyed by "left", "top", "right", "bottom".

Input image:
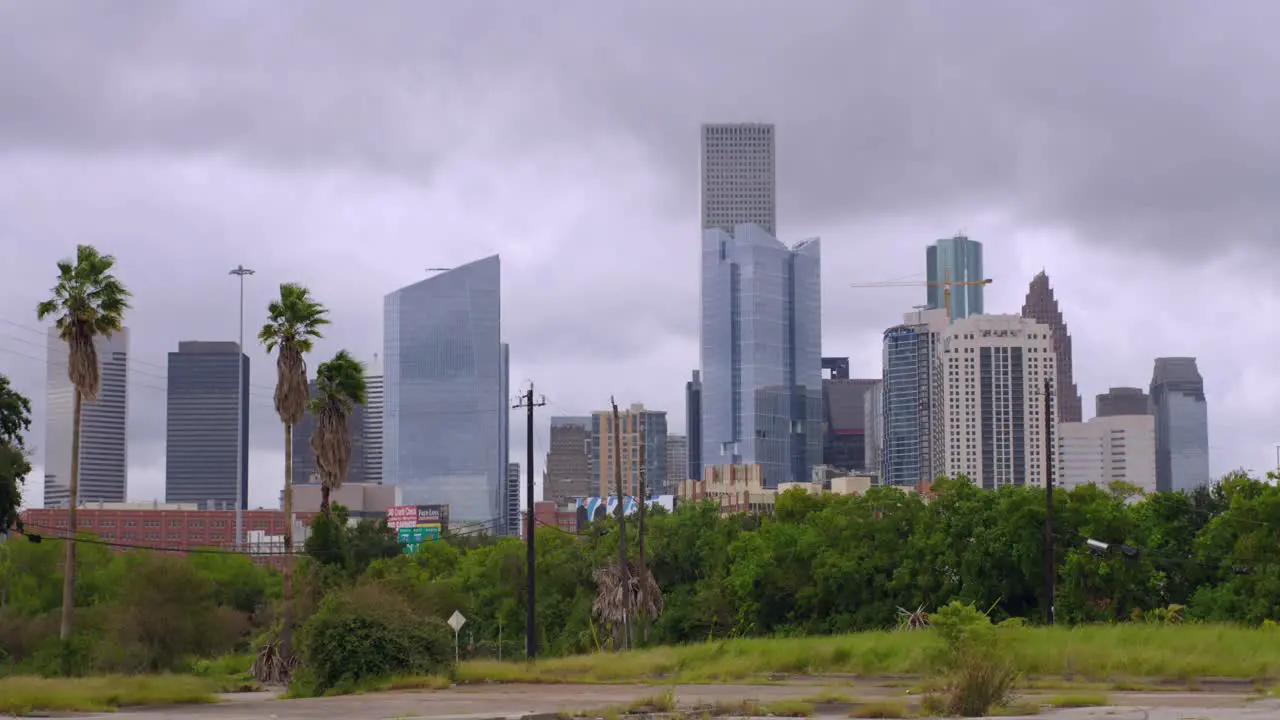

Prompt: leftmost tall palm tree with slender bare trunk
[{"left": 36, "top": 245, "right": 131, "bottom": 673}]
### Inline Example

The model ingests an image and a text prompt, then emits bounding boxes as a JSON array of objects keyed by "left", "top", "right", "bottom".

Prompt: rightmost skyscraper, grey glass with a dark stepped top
[{"left": 1151, "top": 357, "right": 1211, "bottom": 492}]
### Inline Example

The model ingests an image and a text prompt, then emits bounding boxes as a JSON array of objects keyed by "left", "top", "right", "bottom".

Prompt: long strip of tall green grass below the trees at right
[{"left": 457, "top": 624, "right": 1280, "bottom": 683}]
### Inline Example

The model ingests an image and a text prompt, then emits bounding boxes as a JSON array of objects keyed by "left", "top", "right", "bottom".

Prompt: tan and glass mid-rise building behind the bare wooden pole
[{"left": 591, "top": 404, "right": 667, "bottom": 497}]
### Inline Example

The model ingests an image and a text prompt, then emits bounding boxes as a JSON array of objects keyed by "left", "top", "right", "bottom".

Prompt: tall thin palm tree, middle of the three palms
[{"left": 257, "top": 283, "right": 329, "bottom": 662}]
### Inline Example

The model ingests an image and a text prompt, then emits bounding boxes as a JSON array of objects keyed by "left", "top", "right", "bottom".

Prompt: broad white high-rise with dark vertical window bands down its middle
[{"left": 940, "top": 315, "right": 1056, "bottom": 489}]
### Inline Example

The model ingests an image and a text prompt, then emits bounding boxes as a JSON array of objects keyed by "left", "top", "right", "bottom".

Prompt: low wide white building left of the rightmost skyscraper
[{"left": 1057, "top": 415, "right": 1156, "bottom": 492}]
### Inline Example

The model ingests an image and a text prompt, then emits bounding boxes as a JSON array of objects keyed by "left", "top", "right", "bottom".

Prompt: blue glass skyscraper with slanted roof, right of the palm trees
[{"left": 383, "top": 255, "right": 511, "bottom": 527}]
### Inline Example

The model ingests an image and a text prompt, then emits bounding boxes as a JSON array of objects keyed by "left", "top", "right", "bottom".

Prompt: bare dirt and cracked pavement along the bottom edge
[{"left": 72, "top": 683, "right": 1280, "bottom": 720}]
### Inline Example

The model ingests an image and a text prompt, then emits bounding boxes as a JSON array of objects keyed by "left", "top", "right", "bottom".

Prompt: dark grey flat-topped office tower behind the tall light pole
[{"left": 164, "top": 341, "right": 250, "bottom": 509}]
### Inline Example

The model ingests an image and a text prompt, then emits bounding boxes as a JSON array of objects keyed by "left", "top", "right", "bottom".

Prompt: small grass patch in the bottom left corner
[{"left": 0, "top": 675, "right": 219, "bottom": 715}]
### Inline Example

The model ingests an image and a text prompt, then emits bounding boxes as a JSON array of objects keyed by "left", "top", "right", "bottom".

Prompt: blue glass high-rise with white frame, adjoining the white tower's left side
[{"left": 879, "top": 309, "right": 947, "bottom": 486}]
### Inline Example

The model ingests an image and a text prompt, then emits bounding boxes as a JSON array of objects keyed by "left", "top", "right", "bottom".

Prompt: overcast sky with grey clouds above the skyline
[{"left": 0, "top": 0, "right": 1280, "bottom": 505}]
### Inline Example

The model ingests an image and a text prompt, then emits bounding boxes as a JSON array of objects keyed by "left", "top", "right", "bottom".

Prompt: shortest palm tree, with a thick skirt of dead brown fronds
[{"left": 308, "top": 350, "right": 365, "bottom": 518}]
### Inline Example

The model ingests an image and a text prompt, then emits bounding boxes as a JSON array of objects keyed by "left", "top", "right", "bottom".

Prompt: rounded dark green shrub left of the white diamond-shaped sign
[{"left": 296, "top": 583, "right": 453, "bottom": 694}]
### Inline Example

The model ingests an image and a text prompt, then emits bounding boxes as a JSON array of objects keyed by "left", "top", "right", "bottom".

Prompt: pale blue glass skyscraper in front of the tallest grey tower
[{"left": 700, "top": 224, "right": 822, "bottom": 487}]
